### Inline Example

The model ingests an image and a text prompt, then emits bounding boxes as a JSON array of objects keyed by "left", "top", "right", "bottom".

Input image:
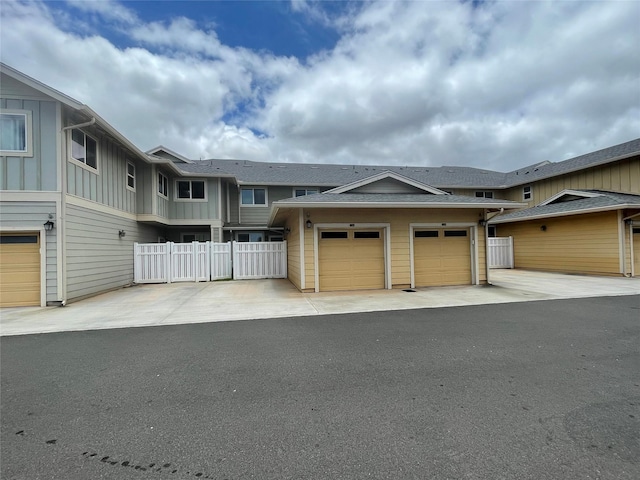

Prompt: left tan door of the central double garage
[{"left": 318, "top": 229, "right": 385, "bottom": 292}]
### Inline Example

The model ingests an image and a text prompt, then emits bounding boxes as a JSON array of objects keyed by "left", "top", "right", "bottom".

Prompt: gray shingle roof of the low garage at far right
[{"left": 489, "top": 190, "right": 640, "bottom": 224}]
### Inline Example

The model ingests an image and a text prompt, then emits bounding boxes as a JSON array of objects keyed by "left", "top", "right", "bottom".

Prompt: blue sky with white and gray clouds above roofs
[{"left": 0, "top": 0, "right": 640, "bottom": 171}]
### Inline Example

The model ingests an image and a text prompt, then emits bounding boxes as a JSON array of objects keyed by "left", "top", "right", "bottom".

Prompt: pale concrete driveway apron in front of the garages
[{"left": 0, "top": 270, "right": 640, "bottom": 336}]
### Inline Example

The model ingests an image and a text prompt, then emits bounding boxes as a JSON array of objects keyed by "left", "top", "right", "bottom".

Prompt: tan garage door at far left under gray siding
[{"left": 0, "top": 233, "right": 40, "bottom": 307}]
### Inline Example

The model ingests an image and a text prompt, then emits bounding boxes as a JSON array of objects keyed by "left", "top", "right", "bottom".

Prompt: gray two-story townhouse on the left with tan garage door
[{"left": 0, "top": 64, "right": 235, "bottom": 306}]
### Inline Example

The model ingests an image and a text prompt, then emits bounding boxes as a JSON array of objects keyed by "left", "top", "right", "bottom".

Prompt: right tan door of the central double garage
[{"left": 413, "top": 228, "right": 471, "bottom": 287}]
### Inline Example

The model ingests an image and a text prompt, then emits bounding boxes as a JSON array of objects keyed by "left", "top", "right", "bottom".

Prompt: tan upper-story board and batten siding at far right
[{"left": 504, "top": 157, "right": 640, "bottom": 207}]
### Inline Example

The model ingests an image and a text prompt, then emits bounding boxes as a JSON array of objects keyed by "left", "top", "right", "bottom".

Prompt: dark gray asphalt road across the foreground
[{"left": 0, "top": 296, "right": 640, "bottom": 480}]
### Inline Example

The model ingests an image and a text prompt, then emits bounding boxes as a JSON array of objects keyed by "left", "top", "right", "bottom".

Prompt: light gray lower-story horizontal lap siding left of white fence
[{"left": 66, "top": 205, "right": 158, "bottom": 300}]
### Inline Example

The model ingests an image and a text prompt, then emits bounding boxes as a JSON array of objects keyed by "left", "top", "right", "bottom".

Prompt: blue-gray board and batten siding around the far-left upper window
[{"left": 0, "top": 95, "right": 58, "bottom": 191}]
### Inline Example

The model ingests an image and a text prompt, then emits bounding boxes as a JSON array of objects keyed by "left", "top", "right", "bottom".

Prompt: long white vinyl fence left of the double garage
[{"left": 134, "top": 242, "right": 287, "bottom": 283}]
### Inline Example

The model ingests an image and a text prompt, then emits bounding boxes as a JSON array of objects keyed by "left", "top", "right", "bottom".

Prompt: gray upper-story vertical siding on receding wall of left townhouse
[{"left": 67, "top": 122, "right": 141, "bottom": 213}]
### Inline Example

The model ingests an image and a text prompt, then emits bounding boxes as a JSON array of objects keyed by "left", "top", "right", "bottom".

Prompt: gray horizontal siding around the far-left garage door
[{"left": 0, "top": 201, "right": 60, "bottom": 302}]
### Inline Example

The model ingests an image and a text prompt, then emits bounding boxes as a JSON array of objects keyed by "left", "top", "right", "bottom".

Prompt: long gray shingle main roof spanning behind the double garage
[{"left": 178, "top": 138, "right": 640, "bottom": 189}]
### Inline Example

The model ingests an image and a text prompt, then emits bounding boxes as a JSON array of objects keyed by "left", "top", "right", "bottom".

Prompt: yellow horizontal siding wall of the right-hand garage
[{"left": 498, "top": 212, "right": 621, "bottom": 275}]
